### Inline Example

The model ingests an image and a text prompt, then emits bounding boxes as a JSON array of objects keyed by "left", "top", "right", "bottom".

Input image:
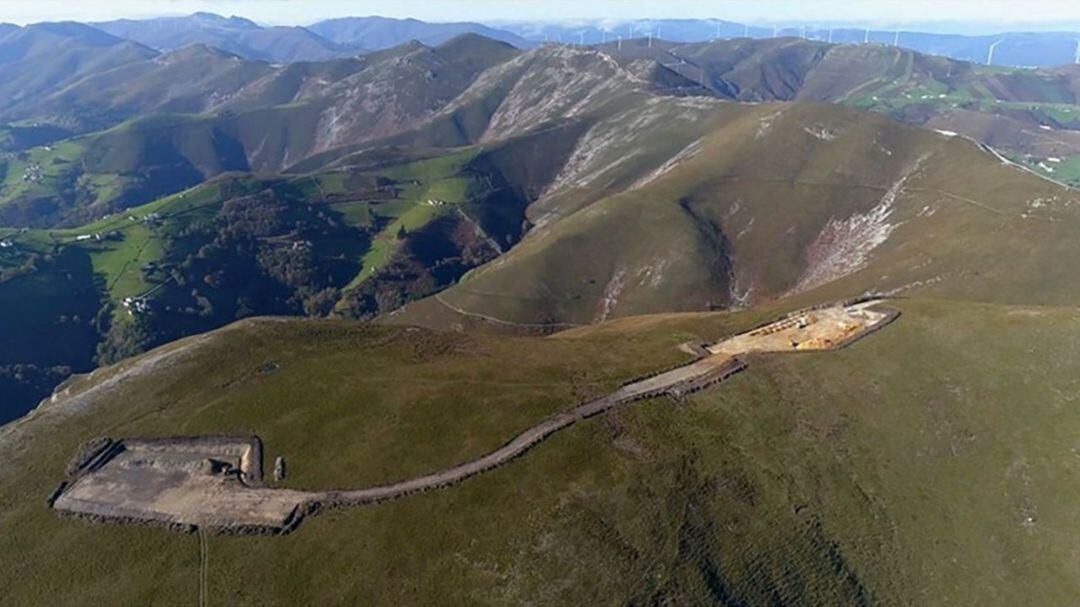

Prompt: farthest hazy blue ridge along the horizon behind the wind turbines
[{"left": 0, "top": 13, "right": 1078, "bottom": 68}]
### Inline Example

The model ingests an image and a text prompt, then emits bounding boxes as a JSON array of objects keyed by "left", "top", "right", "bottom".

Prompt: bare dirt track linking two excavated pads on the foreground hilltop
[{"left": 49, "top": 299, "right": 900, "bottom": 534}]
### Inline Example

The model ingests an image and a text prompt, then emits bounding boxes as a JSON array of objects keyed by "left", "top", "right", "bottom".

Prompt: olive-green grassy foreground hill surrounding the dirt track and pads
[{"left": 0, "top": 300, "right": 1080, "bottom": 606}]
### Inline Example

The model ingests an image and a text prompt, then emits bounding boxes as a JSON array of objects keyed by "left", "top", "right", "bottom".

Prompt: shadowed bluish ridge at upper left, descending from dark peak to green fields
[{"left": 0, "top": 35, "right": 515, "bottom": 226}]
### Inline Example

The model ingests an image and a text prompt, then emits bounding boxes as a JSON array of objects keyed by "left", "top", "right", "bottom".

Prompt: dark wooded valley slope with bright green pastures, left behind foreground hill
[{"left": 0, "top": 143, "right": 535, "bottom": 419}]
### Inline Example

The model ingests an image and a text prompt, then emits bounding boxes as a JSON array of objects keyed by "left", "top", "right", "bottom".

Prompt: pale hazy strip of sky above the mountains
[{"left": 6, "top": 0, "right": 1080, "bottom": 29}]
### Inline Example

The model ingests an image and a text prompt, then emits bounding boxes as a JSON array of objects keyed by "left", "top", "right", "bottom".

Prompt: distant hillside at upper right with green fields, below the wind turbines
[{"left": 604, "top": 38, "right": 1080, "bottom": 179}]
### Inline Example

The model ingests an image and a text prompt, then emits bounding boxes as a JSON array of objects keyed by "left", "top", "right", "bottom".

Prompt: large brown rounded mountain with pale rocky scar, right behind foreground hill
[{"left": 393, "top": 99, "right": 1080, "bottom": 327}]
